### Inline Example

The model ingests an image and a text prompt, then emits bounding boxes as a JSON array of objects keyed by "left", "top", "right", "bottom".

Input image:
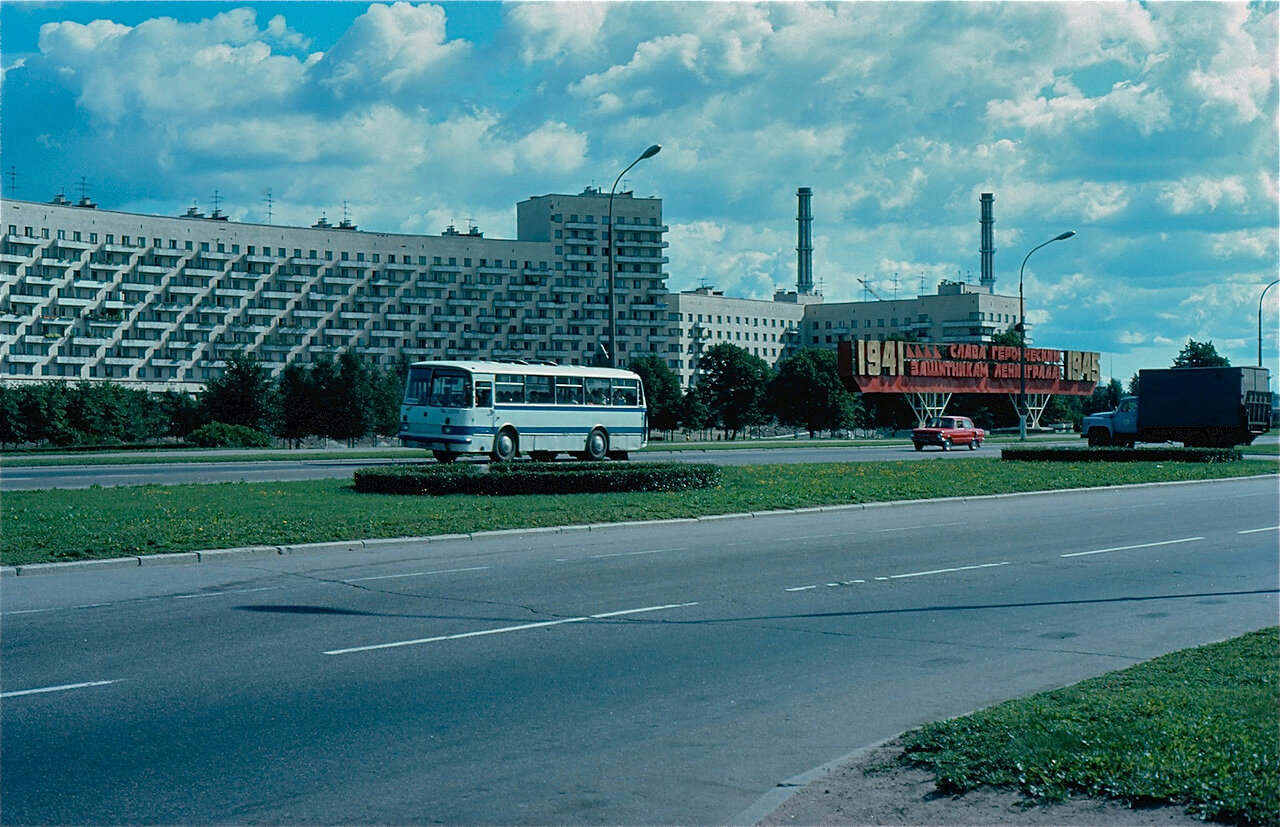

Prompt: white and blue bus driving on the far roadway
[{"left": 399, "top": 361, "right": 648, "bottom": 462}]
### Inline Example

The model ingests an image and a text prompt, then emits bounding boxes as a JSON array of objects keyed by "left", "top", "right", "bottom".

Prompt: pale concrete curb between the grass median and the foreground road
[{"left": 0, "top": 474, "right": 1275, "bottom": 577}]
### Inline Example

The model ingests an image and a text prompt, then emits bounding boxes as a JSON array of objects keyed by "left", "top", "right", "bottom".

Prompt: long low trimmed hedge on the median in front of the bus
[{"left": 355, "top": 462, "right": 721, "bottom": 497}]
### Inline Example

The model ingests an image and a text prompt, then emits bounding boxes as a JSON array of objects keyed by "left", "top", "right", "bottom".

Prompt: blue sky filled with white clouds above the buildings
[{"left": 0, "top": 0, "right": 1280, "bottom": 379}]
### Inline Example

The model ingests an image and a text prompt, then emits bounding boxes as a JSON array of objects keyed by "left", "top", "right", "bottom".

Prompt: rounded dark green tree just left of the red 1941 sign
[{"left": 767, "top": 348, "right": 867, "bottom": 439}]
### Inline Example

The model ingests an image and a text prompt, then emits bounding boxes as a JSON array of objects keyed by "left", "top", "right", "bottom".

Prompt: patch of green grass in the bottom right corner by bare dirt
[{"left": 906, "top": 627, "right": 1280, "bottom": 824}]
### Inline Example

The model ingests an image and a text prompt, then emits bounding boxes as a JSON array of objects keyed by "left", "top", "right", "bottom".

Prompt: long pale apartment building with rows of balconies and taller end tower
[{"left": 0, "top": 188, "right": 669, "bottom": 390}]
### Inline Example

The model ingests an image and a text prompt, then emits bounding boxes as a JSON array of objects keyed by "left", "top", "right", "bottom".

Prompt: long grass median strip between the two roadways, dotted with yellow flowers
[{"left": 0, "top": 458, "right": 1276, "bottom": 566}]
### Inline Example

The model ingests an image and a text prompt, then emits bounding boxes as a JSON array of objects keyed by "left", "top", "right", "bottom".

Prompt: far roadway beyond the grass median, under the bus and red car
[{"left": 0, "top": 440, "right": 1054, "bottom": 492}]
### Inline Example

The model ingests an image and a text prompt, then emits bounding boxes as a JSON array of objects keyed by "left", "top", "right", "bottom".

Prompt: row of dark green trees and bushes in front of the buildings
[{"left": 0, "top": 333, "right": 1226, "bottom": 446}]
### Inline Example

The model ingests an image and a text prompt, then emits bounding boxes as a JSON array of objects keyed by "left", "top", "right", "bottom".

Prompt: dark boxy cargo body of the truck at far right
[{"left": 1138, "top": 367, "right": 1271, "bottom": 433}]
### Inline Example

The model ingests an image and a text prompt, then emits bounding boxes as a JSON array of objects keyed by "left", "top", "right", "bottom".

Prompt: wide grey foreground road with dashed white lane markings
[{"left": 0, "top": 479, "right": 1280, "bottom": 824}]
